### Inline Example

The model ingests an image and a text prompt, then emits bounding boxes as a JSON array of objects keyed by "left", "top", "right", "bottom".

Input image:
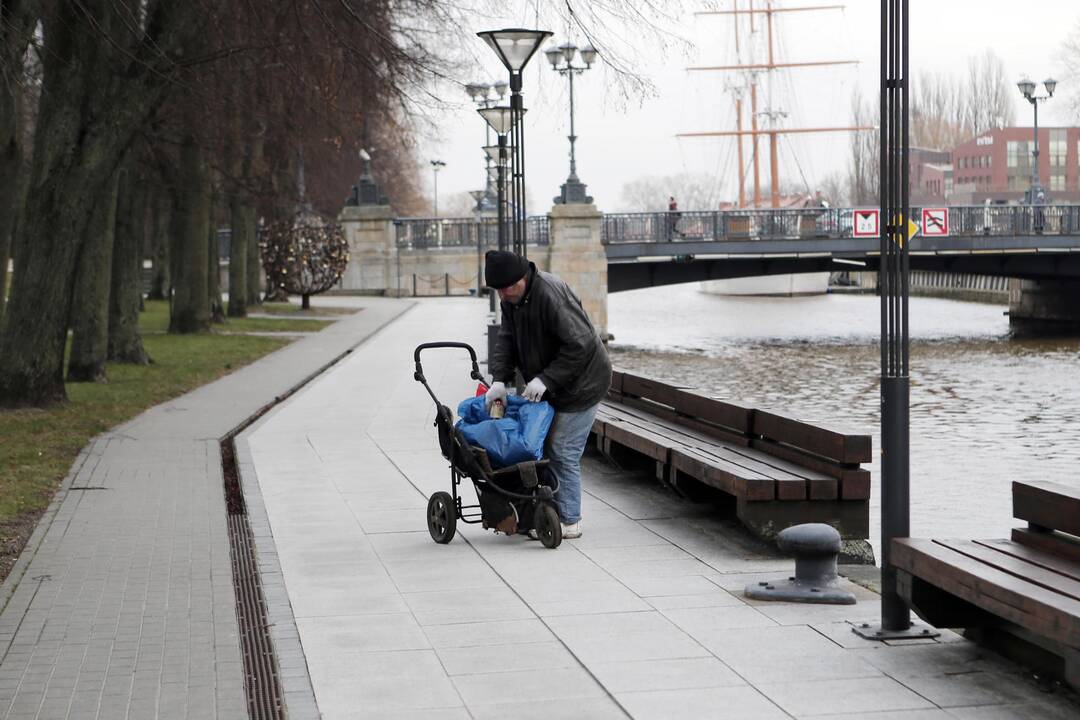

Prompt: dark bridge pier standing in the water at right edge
[{"left": 1009, "top": 279, "right": 1080, "bottom": 336}]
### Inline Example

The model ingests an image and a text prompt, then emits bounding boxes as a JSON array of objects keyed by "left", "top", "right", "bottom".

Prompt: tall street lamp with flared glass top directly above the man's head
[{"left": 476, "top": 28, "right": 551, "bottom": 257}]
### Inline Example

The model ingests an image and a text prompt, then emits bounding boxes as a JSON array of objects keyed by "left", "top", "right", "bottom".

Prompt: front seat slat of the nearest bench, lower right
[{"left": 891, "top": 538, "right": 1080, "bottom": 648}]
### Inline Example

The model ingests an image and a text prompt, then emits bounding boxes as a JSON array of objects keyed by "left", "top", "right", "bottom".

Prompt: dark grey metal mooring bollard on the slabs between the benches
[{"left": 745, "top": 522, "right": 855, "bottom": 604}]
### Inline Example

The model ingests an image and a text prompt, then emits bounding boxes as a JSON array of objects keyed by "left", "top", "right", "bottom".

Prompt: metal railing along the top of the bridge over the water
[{"left": 600, "top": 205, "right": 1080, "bottom": 244}]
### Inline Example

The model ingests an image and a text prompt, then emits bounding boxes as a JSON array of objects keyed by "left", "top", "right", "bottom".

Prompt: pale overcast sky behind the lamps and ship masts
[{"left": 408, "top": 0, "right": 1080, "bottom": 214}]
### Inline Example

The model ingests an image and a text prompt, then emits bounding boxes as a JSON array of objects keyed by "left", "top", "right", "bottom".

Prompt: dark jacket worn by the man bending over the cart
[{"left": 489, "top": 262, "right": 611, "bottom": 412}]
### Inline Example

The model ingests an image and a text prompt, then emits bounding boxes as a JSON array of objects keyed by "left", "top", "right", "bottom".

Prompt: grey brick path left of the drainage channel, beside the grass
[{"left": 0, "top": 299, "right": 410, "bottom": 720}]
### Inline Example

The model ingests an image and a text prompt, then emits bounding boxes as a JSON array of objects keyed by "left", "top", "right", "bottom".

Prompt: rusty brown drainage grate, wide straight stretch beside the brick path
[{"left": 221, "top": 435, "right": 285, "bottom": 720}]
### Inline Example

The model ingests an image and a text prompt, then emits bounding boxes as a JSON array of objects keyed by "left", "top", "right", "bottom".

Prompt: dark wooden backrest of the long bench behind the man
[{"left": 608, "top": 371, "right": 872, "bottom": 472}]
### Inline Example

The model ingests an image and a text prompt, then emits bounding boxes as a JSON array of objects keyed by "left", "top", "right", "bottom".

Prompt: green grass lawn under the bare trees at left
[{"left": 0, "top": 301, "right": 345, "bottom": 580}]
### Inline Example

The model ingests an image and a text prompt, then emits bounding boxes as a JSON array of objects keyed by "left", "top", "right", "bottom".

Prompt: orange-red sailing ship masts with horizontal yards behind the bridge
[{"left": 676, "top": 0, "right": 874, "bottom": 207}]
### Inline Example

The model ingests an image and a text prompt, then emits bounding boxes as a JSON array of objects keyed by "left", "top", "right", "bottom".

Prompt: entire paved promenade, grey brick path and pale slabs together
[{"left": 0, "top": 298, "right": 1080, "bottom": 720}]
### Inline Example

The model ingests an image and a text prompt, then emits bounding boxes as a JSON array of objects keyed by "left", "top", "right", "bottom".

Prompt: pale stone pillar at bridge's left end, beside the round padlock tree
[{"left": 336, "top": 205, "right": 404, "bottom": 295}]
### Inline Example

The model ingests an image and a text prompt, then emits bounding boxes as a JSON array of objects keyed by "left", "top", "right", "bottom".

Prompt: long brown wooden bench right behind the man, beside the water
[{"left": 593, "top": 371, "right": 870, "bottom": 539}]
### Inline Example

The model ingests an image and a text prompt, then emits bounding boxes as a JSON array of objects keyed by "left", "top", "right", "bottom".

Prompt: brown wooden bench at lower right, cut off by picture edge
[{"left": 892, "top": 481, "right": 1080, "bottom": 687}]
